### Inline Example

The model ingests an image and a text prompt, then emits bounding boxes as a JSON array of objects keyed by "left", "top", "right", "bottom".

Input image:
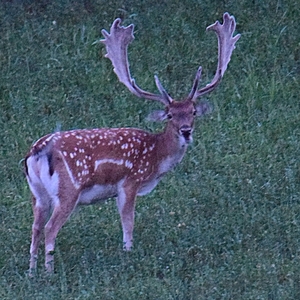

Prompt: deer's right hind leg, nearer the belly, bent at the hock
[{"left": 45, "top": 189, "right": 78, "bottom": 273}]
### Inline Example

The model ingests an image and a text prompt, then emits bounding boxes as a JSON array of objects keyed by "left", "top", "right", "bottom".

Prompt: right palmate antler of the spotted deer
[{"left": 189, "top": 13, "right": 241, "bottom": 100}]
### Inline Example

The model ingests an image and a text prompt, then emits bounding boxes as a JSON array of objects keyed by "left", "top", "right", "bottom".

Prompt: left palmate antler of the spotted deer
[{"left": 101, "top": 18, "right": 172, "bottom": 105}]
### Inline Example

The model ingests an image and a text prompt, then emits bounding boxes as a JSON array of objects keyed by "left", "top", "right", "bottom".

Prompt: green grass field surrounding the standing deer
[{"left": 0, "top": 0, "right": 300, "bottom": 300}]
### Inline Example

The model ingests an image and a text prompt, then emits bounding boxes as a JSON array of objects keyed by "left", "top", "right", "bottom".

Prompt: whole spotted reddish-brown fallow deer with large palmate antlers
[{"left": 25, "top": 13, "right": 240, "bottom": 272}]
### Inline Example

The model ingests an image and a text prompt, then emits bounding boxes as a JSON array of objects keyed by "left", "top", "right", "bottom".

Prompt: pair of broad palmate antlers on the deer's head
[{"left": 101, "top": 13, "right": 240, "bottom": 106}]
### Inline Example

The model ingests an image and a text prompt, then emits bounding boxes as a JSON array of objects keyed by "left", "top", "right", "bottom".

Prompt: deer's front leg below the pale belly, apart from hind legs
[{"left": 117, "top": 184, "right": 137, "bottom": 251}]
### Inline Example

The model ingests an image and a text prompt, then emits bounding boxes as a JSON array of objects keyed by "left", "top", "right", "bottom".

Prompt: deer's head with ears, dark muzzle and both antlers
[{"left": 101, "top": 13, "right": 240, "bottom": 143}]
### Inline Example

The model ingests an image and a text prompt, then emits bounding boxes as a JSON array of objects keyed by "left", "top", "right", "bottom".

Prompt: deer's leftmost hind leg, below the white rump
[{"left": 29, "top": 197, "right": 50, "bottom": 275}]
